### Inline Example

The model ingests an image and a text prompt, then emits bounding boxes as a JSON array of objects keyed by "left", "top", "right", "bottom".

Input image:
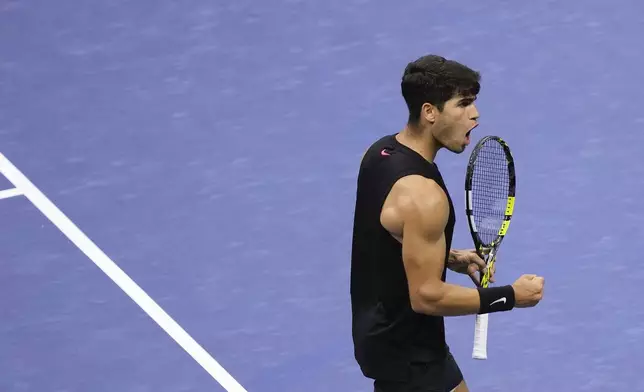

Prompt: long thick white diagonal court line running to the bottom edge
[{"left": 0, "top": 154, "right": 246, "bottom": 392}]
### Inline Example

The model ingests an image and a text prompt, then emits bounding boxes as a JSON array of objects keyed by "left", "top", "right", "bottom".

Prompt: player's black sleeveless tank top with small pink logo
[{"left": 351, "top": 135, "right": 456, "bottom": 380}]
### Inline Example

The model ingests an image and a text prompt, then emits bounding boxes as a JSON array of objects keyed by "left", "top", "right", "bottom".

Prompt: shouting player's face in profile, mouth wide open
[{"left": 432, "top": 96, "right": 479, "bottom": 154}]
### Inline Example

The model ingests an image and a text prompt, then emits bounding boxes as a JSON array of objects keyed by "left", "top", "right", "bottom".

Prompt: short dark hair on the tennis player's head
[{"left": 401, "top": 55, "right": 481, "bottom": 124}]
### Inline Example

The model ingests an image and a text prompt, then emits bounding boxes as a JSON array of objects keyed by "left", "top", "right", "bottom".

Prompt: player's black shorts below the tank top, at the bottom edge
[{"left": 374, "top": 353, "right": 463, "bottom": 392}]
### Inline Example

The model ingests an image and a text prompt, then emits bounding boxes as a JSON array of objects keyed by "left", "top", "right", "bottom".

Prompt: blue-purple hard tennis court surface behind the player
[{"left": 0, "top": 0, "right": 644, "bottom": 392}]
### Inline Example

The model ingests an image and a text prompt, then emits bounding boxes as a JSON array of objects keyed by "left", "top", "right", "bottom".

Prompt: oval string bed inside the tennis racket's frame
[{"left": 472, "top": 141, "right": 510, "bottom": 245}]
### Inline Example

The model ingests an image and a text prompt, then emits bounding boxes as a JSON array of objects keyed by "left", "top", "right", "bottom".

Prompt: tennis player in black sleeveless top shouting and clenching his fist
[{"left": 351, "top": 55, "right": 544, "bottom": 392}]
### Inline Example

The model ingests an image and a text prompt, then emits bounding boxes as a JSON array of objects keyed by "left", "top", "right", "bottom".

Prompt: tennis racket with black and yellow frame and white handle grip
[{"left": 465, "top": 136, "right": 516, "bottom": 359}]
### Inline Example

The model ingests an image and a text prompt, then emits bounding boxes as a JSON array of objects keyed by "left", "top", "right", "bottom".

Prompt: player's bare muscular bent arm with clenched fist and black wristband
[{"left": 392, "top": 176, "right": 543, "bottom": 316}]
